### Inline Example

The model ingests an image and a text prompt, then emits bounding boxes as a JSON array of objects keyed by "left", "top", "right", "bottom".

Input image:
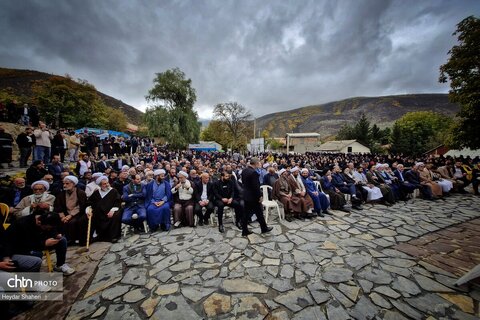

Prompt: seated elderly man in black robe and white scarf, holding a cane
[{"left": 89, "top": 176, "right": 122, "bottom": 243}]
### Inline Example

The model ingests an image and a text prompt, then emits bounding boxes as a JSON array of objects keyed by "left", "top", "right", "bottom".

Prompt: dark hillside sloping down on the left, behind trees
[{"left": 0, "top": 68, "right": 143, "bottom": 125}]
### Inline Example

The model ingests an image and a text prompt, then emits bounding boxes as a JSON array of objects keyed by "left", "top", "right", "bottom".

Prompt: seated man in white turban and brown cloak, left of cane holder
[{"left": 55, "top": 176, "right": 88, "bottom": 246}]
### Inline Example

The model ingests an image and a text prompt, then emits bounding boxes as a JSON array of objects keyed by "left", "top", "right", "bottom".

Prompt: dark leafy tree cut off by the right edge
[{"left": 439, "top": 16, "right": 480, "bottom": 149}]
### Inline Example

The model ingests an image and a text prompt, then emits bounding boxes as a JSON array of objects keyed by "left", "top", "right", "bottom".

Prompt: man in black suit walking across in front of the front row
[{"left": 242, "top": 157, "right": 273, "bottom": 236}]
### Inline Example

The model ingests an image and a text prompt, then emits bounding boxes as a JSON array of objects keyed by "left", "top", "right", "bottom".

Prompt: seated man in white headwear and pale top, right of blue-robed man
[{"left": 172, "top": 171, "right": 195, "bottom": 228}]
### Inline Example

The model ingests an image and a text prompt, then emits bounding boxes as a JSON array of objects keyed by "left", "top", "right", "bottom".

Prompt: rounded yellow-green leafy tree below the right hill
[{"left": 391, "top": 111, "right": 452, "bottom": 155}]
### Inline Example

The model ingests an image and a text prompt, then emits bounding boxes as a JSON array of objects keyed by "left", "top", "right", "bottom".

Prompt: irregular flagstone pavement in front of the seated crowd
[{"left": 67, "top": 195, "right": 480, "bottom": 320}]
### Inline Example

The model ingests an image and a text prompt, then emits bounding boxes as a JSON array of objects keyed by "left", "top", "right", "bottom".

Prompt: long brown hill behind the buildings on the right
[{"left": 256, "top": 94, "right": 459, "bottom": 138}]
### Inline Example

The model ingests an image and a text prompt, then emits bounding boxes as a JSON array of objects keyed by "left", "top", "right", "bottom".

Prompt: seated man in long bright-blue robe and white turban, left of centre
[{"left": 144, "top": 169, "right": 172, "bottom": 232}]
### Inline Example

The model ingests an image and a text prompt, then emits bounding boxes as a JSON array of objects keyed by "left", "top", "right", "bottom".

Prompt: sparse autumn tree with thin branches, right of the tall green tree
[{"left": 213, "top": 102, "right": 252, "bottom": 149}]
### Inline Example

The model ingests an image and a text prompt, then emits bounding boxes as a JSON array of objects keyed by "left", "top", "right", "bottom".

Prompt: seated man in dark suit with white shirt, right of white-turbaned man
[{"left": 194, "top": 172, "right": 215, "bottom": 226}]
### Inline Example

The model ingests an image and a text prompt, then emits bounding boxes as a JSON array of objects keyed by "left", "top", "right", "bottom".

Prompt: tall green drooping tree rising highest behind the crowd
[{"left": 145, "top": 68, "right": 200, "bottom": 148}]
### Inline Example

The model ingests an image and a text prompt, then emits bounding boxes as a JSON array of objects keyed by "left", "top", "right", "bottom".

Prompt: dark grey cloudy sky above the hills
[{"left": 0, "top": 0, "right": 480, "bottom": 118}]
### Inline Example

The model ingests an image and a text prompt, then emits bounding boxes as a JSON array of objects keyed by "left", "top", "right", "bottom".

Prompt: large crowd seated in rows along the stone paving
[{"left": 0, "top": 149, "right": 480, "bottom": 290}]
